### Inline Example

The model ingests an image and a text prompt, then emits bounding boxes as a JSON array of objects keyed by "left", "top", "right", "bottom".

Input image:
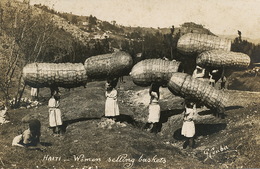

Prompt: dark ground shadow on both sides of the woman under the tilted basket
[{"left": 173, "top": 123, "right": 227, "bottom": 140}]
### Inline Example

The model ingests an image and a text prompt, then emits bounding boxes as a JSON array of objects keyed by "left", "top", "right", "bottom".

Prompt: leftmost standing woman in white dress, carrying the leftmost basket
[{"left": 48, "top": 92, "right": 62, "bottom": 134}]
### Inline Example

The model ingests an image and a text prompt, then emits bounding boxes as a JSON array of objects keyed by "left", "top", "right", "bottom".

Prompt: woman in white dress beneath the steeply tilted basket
[{"left": 181, "top": 100, "right": 196, "bottom": 149}]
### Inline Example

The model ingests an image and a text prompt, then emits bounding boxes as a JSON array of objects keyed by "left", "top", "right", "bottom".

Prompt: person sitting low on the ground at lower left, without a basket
[{"left": 12, "top": 120, "right": 44, "bottom": 150}]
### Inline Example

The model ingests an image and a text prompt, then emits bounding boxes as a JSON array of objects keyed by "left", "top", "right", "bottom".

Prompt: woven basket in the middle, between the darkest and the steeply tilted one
[{"left": 131, "top": 59, "right": 181, "bottom": 86}]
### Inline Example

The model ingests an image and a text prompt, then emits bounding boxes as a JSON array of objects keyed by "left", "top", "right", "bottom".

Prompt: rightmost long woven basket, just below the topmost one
[{"left": 196, "top": 50, "right": 250, "bottom": 68}]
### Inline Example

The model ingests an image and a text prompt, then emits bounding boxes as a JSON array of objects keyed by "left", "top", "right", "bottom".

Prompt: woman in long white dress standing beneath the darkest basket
[{"left": 105, "top": 82, "right": 120, "bottom": 120}]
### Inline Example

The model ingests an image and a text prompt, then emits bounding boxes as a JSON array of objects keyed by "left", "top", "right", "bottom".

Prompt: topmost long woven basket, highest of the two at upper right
[{"left": 177, "top": 33, "right": 231, "bottom": 54}]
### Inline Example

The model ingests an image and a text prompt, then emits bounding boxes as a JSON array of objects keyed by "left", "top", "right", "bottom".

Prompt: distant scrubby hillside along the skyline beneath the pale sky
[{"left": 34, "top": 4, "right": 213, "bottom": 47}]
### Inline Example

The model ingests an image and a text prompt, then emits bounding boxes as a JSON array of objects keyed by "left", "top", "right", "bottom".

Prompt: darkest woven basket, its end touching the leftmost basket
[{"left": 84, "top": 51, "right": 133, "bottom": 79}]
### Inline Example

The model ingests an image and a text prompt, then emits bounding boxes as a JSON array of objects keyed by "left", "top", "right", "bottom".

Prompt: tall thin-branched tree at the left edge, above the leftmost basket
[{"left": 0, "top": 0, "right": 59, "bottom": 105}]
